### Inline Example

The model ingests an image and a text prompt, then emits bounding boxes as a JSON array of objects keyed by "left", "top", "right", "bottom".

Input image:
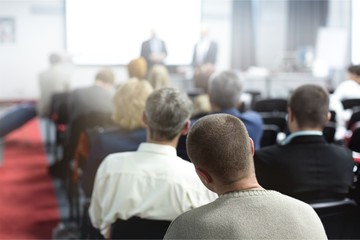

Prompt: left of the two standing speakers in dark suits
[{"left": 140, "top": 30, "right": 167, "bottom": 69}]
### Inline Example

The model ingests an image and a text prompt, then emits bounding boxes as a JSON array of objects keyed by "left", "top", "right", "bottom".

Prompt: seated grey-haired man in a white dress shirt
[{"left": 89, "top": 88, "right": 216, "bottom": 238}]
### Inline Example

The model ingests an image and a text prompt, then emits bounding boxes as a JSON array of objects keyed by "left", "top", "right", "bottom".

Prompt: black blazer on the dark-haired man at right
[{"left": 254, "top": 135, "right": 355, "bottom": 203}]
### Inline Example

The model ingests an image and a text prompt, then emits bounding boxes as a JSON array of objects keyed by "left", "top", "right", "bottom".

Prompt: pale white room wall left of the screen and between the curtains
[{"left": 0, "top": 0, "right": 350, "bottom": 100}]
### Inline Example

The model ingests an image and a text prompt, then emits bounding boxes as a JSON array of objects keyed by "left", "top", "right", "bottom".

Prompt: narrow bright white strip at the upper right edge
[{"left": 351, "top": 0, "right": 360, "bottom": 64}]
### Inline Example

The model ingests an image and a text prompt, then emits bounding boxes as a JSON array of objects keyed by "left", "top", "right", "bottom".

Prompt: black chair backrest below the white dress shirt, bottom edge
[{"left": 111, "top": 217, "right": 171, "bottom": 239}]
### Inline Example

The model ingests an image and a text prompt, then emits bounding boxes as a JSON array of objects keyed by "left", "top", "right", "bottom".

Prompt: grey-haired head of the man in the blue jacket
[{"left": 209, "top": 71, "right": 243, "bottom": 109}]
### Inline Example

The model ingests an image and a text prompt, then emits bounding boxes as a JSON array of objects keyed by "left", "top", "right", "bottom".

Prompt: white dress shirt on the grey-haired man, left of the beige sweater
[{"left": 89, "top": 143, "right": 217, "bottom": 237}]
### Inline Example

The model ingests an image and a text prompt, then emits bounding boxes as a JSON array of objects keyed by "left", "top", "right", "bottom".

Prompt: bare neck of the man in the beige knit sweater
[{"left": 214, "top": 173, "right": 262, "bottom": 195}]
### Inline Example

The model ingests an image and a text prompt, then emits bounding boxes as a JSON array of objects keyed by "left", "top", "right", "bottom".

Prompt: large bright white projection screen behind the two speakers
[{"left": 66, "top": 0, "right": 201, "bottom": 65}]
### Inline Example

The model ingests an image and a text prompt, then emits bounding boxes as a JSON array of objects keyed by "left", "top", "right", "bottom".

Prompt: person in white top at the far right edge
[{"left": 332, "top": 65, "right": 360, "bottom": 101}]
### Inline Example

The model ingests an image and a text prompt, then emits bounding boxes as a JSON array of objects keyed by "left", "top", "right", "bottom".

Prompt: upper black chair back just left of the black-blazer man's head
[{"left": 253, "top": 98, "right": 287, "bottom": 113}]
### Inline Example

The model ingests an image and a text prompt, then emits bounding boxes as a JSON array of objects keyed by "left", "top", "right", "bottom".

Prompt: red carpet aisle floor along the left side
[{"left": 0, "top": 119, "right": 60, "bottom": 239}]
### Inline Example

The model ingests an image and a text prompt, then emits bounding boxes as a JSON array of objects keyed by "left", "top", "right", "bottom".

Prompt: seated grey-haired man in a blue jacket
[{"left": 205, "top": 71, "right": 263, "bottom": 149}]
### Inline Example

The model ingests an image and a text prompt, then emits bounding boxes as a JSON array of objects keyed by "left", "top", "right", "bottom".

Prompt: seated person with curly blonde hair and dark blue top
[{"left": 82, "top": 79, "right": 153, "bottom": 197}]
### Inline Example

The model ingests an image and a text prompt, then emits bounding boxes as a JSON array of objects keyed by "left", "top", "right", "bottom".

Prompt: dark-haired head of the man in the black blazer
[{"left": 288, "top": 84, "right": 329, "bottom": 129}]
